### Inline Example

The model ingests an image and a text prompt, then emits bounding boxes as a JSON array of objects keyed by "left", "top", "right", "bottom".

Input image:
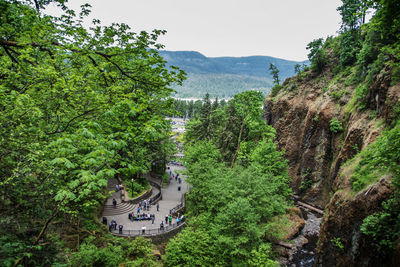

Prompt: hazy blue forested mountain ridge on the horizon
[{"left": 159, "top": 51, "right": 308, "bottom": 97}]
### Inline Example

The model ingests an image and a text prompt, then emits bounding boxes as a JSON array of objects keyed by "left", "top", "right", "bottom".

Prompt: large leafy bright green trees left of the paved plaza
[{"left": 0, "top": 0, "right": 184, "bottom": 266}]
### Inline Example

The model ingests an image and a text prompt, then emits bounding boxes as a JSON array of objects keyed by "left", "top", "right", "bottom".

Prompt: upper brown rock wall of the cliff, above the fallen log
[{"left": 264, "top": 68, "right": 399, "bottom": 208}]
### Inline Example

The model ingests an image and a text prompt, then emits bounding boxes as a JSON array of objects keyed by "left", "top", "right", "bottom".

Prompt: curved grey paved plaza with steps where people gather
[{"left": 100, "top": 165, "right": 187, "bottom": 230}]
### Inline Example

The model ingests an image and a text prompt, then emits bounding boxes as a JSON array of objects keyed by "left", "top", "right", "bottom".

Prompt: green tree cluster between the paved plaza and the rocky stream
[{"left": 166, "top": 91, "right": 291, "bottom": 266}]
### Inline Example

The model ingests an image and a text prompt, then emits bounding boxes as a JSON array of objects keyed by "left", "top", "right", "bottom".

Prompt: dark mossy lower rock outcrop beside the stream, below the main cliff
[{"left": 316, "top": 177, "right": 393, "bottom": 267}]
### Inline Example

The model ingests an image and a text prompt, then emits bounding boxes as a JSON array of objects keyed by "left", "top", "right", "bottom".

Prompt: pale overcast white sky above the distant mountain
[{"left": 49, "top": 0, "right": 341, "bottom": 61}]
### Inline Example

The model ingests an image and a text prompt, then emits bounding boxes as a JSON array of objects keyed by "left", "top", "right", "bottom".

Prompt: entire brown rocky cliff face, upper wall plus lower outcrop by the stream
[{"left": 264, "top": 64, "right": 400, "bottom": 266}]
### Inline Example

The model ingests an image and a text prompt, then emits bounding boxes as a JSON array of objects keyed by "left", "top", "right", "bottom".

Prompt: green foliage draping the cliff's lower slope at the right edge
[{"left": 350, "top": 121, "right": 400, "bottom": 255}]
